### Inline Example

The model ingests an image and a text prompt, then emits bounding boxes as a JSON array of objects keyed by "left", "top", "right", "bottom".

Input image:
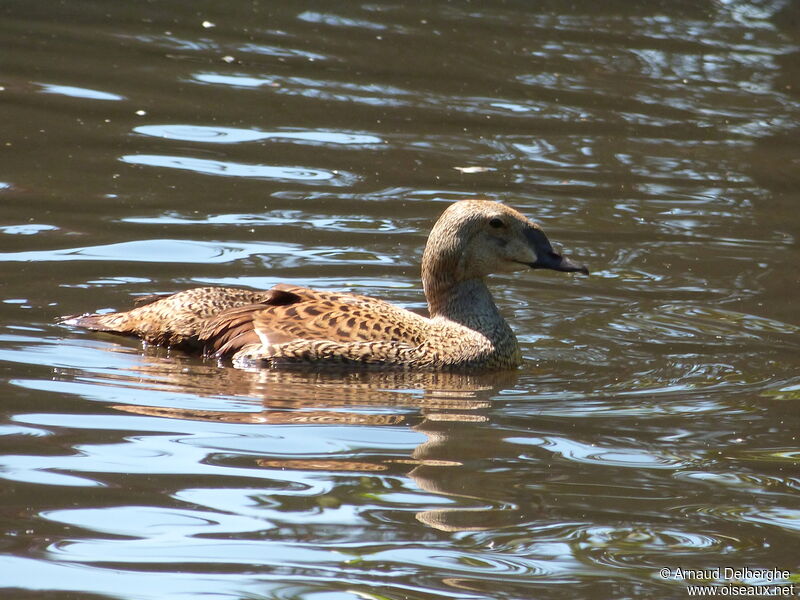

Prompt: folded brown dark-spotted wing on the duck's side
[{"left": 198, "top": 284, "right": 428, "bottom": 357}]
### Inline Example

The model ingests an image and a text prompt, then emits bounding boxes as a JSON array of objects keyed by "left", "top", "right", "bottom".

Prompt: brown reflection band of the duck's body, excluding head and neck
[{"left": 97, "top": 354, "right": 519, "bottom": 410}]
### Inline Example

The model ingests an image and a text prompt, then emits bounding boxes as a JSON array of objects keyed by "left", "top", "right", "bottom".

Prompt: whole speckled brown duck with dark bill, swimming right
[{"left": 62, "top": 199, "right": 589, "bottom": 371}]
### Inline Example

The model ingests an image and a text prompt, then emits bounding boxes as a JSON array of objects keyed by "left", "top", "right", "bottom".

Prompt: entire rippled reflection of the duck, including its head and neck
[{"left": 84, "top": 348, "right": 530, "bottom": 531}]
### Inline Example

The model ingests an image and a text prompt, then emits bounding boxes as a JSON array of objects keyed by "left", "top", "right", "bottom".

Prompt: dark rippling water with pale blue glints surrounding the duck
[{"left": 0, "top": 0, "right": 800, "bottom": 600}]
